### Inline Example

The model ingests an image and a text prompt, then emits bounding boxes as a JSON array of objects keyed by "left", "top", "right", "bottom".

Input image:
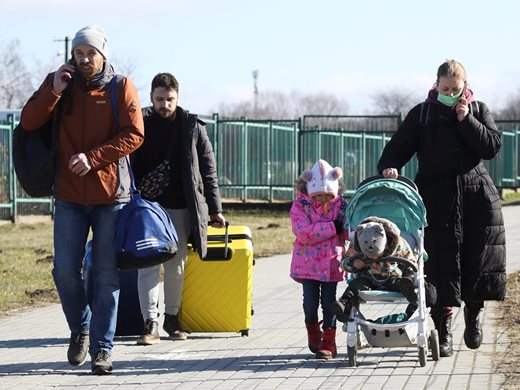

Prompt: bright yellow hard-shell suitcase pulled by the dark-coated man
[{"left": 179, "top": 223, "right": 253, "bottom": 336}]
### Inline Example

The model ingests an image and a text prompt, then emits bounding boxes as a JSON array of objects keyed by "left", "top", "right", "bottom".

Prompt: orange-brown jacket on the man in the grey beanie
[{"left": 21, "top": 67, "right": 144, "bottom": 205}]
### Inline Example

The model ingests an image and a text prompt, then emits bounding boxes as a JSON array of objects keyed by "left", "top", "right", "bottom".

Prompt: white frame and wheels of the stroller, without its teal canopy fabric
[{"left": 346, "top": 176, "right": 439, "bottom": 367}]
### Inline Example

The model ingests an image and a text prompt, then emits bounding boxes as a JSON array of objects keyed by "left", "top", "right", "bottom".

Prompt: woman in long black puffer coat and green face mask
[{"left": 377, "top": 60, "right": 506, "bottom": 356}]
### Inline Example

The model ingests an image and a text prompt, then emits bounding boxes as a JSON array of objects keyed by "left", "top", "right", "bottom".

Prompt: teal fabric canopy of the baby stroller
[{"left": 347, "top": 176, "right": 427, "bottom": 247}]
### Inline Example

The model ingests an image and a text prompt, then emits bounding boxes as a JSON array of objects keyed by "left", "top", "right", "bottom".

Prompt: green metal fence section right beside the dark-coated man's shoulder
[{"left": 204, "top": 114, "right": 300, "bottom": 202}]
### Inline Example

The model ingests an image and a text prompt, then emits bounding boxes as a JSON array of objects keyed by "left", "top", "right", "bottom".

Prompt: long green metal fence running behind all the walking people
[{"left": 0, "top": 114, "right": 520, "bottom": 220}]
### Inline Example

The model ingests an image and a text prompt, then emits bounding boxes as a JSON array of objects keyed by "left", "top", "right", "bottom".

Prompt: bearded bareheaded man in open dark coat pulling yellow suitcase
[{"left": 132, "top": 73, "right": 225, "bottom": 345}]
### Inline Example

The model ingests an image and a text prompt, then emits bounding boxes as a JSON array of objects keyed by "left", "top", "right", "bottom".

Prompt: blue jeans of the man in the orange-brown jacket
[{"left": 52, "top": 200, "right": 124, "bottom": 356}]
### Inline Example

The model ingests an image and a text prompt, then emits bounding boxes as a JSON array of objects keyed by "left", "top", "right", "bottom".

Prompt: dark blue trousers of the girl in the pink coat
[{"left": 302, "top": 279, "right": 338, "bottom": 329}]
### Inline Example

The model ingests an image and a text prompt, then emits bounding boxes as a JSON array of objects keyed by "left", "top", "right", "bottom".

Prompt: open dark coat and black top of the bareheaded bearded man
[{"left": 132, "top": 107, "right": 222, "bottom": 257}]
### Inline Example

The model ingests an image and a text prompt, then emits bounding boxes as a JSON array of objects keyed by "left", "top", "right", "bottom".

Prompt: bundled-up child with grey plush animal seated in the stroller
[{"left": 331, "top": 216, "right": 418, "bottom": 322}]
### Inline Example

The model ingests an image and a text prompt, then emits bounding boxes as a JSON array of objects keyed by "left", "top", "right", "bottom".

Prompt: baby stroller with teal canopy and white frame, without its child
[{"left": 343, "top": 176, "right": 439, "bottom": 367}]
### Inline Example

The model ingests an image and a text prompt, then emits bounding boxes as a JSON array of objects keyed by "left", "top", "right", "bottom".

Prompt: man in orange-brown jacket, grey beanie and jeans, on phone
[{"left": 21, "top": 26, "right": 144, "bottom": 375}]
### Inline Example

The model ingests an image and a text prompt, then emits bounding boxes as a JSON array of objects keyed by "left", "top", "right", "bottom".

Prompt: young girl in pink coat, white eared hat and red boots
[{"left": 290, "top": 160, "right": 348, "bottom": 359}]
